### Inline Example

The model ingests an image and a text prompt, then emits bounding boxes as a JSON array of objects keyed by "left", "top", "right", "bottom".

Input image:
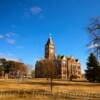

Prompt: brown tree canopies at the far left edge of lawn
[{"left": 0, "top": 58, "right": 28, "bottom": 78}]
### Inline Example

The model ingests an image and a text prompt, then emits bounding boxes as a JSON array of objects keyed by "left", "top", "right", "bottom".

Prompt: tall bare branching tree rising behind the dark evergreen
[{"left": 87, "top": 16, "right": 100, "bottom": 61}]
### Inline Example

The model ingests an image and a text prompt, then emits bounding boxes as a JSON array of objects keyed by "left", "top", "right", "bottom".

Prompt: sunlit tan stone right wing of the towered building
[{"left": 61, "top": 56, "right": 81, "bottom": 80}]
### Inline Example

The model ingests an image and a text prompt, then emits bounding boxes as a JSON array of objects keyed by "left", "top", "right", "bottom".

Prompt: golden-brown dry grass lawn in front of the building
[{"left": 0, "top": 79, "right": 100, "bottom": 100}]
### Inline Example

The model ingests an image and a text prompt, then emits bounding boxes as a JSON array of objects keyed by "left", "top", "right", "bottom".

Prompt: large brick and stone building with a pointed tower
[{"left": 35, "top": 36, "right": 81, "bottom": 80}]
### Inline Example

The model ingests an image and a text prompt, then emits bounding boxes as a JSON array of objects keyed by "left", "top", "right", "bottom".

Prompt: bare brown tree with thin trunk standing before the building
[{"left": 35, "top": 59, "right": 60, "bottom": 93}]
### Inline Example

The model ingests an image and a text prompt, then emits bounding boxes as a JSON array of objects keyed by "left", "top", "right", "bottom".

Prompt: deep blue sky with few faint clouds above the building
[{"left": 0, "top": 0, "right": 100, "bottom": 70}]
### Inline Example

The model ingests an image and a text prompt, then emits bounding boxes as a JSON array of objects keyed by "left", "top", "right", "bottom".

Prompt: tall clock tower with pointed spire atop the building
[{"left": 45, "top": 36, "right": 55, "bottom": 59}]
